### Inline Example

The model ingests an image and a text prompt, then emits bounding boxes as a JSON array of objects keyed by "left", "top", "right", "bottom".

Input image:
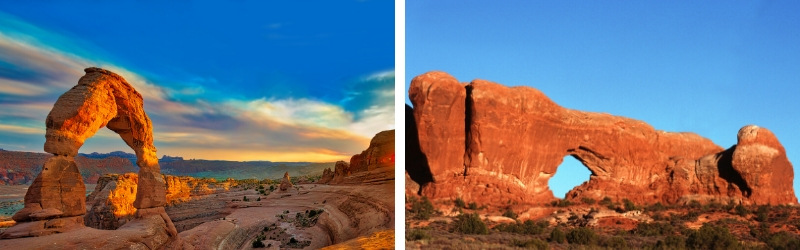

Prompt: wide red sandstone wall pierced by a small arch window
[{"left": 406, "top": 72, "right": 797, "bottom": 206}]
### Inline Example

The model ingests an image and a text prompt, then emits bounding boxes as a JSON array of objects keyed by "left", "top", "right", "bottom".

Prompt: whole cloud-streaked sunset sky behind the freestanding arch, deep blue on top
[{"left": 0, "top": 0, "right": 394, "bottom": 161}]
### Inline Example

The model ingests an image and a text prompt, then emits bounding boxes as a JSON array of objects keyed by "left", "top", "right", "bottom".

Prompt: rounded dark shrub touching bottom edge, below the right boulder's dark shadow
[{"left": 686, "top": 223, "right": 741, "bottom": 249}]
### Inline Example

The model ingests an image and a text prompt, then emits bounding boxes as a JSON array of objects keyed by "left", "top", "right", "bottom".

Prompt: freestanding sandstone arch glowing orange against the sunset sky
[{"left": 0, "top": 68, "right": 177, "bottom": 248}]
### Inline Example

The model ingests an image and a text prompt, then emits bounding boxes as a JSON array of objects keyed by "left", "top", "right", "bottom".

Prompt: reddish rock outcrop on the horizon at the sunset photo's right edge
[{"left": 317, "top": 129, "right": 394, "bottom": 184}]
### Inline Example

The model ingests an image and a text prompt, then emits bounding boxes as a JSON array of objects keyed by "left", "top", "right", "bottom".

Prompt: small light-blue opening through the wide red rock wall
[{"left": 547, "top": 155, "right": 592, "bottom": 199}]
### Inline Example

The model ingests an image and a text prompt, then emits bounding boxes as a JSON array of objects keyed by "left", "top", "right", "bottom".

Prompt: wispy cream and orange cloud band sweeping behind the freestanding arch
[{"left": 0, "top": 13, "right": 394, "bottom": 161}]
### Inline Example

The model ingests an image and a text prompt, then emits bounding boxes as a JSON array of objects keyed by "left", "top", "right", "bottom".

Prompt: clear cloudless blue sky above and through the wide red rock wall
[{"left": 405, "top": 0, "right": 800, "bottom": 197}]
